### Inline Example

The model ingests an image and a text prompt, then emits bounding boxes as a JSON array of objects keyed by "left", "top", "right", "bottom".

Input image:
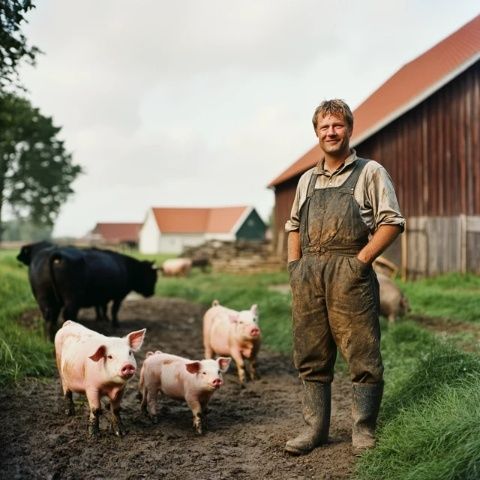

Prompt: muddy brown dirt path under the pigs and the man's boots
[{"left": 0, "top": 298, "right": 354, "bottom": 480}]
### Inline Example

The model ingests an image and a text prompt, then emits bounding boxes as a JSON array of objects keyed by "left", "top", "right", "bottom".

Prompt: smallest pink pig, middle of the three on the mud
[{"left": 139, "top": 350, "right": 231, "bottom": 435}]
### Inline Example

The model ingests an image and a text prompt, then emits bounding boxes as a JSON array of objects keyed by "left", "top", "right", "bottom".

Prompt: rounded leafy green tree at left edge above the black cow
[{"left": 0, "top": 93, "right": 82, "bottom": 239}]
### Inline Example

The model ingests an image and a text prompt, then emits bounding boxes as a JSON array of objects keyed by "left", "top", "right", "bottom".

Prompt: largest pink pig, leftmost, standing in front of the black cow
[{"left": 55, "top": 320, "right": 146, "bottom": 436}]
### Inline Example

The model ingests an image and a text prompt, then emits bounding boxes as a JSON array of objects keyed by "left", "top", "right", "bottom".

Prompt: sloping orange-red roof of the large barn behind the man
[{"left": 268, "top": 15, "right": 480, "bottom": 187}]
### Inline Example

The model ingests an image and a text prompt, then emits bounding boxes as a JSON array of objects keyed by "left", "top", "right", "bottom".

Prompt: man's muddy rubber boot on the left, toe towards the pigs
[{"left": 285, "top": 382, "right": 331, "bottom": 455}]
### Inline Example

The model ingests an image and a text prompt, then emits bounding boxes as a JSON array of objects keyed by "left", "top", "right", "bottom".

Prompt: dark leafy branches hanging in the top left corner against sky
[{"left": 0, "top": 0, "right": 39, "bottom": 90}]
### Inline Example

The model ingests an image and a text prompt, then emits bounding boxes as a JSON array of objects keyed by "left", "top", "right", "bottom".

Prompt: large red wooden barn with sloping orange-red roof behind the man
[{"left": 268, "top": 15, "right": 480, "bottom": 278}]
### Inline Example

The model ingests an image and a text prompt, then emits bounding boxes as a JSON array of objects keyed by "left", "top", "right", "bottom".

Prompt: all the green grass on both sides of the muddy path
[{"left": 0, "top": 251, "right": 480, "bottom": 480}]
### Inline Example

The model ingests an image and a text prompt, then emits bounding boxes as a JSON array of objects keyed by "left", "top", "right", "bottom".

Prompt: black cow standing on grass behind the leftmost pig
[{"left": 17, "top": 242, "right": 157, "bottom": 340}]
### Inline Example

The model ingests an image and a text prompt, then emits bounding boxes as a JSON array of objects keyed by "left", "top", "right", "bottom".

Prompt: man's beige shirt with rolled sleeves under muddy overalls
[{"left": 285, "top": 150, "right": 405, "bottom": 233}]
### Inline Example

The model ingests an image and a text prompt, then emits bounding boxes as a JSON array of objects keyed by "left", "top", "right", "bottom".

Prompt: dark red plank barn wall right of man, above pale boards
[{"left": 355, "top": 62, "right": 480, "bottom": 217}]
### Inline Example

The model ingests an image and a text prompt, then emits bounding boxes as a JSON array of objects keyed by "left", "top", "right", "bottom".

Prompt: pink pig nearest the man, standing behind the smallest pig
[{"left": 203, "top": 300, "right": 261, "bottom": 388}]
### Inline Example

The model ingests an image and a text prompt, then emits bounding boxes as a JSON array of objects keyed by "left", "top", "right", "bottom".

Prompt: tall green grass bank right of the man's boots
[{"left": 355, "top": 330, "right": 480, "bottom": 480}]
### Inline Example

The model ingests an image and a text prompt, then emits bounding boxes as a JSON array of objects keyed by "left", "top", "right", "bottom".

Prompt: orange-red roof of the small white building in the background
[{"left": 152, "top": 206, "right": 251, "bottom": 233}]
